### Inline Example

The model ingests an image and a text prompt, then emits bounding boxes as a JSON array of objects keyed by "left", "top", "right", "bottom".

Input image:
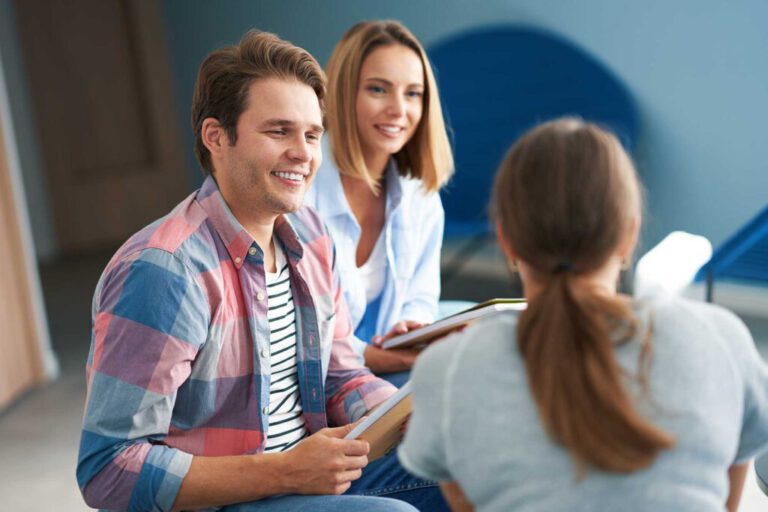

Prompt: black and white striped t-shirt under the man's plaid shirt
[{"left": 264, "top": 240, "right": 307, "bottom": 452}]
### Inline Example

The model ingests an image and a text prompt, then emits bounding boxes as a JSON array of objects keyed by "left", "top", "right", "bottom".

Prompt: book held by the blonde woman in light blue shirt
[{"left": 381, "top": 299, "right": 526, "bottom": 349}]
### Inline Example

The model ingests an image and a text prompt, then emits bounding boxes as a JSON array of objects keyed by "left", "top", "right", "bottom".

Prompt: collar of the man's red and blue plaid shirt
[{"left": 197, "top": 175, "right": 303, "bottom": 268}]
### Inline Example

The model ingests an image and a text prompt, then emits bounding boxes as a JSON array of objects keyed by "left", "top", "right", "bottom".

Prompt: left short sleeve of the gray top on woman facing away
[{"left": 397, "top": 336, "right": 459, "bottom": 482}]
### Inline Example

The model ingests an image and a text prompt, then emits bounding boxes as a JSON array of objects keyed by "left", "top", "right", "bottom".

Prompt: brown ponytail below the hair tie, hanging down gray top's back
[{"left": 518, "top": 269, "right": 674, "bottom": 474}]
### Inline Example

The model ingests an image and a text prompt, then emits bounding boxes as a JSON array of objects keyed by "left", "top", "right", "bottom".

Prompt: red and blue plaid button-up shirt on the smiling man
[{"left": 77, "top": 177, "right": 394, "bottom": 510}]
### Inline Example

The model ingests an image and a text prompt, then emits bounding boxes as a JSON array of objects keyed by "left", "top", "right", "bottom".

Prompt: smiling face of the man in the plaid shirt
[{"left": 214, "top": 78, "right": 323, "bottom": 222}]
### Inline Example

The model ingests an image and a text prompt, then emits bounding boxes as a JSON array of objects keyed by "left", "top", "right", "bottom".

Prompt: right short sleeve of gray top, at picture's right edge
[{"left": 714, "top": 308, "right": 768, "bottom": 464}]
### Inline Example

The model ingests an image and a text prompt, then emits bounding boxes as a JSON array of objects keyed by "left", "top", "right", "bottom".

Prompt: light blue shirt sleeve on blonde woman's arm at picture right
[{"left": 399, "top": 191, "right": 445, "bottom": 323}]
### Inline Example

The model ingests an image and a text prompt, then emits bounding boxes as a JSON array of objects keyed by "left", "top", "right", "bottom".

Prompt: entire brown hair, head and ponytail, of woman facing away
[{"left": 493, "top": 118, "right": 674, "bottom": 473}]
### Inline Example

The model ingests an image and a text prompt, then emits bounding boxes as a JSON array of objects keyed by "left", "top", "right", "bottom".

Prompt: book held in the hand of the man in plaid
[{"left": 345, "top": 381, "right": 411, "bottom": 461}]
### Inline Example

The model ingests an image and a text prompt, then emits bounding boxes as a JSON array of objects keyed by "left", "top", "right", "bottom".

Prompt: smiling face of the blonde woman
[{"left": 355, "top": 44, "right": 424, "bottom": 166}]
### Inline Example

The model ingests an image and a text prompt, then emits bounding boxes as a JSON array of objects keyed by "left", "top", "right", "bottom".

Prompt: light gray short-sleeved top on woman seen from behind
[{"left": 399, "top": 297, "right": 768, "bottom": 512}]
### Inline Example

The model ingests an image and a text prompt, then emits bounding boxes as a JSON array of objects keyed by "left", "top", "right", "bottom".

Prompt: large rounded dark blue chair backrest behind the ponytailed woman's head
[{"left": 428, "top": 25, "right": 637, "bottom": 236}]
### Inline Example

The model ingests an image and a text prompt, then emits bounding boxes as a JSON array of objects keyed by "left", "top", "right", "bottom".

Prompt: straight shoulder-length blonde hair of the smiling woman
[{"left": 326, "top": 21, "right": 453, "bottom": 192}]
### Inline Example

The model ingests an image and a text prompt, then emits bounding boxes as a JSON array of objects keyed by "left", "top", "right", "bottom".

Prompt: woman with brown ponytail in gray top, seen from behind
[{"left": 399, "top": 119, "right": 768, "bottom": 512}]
